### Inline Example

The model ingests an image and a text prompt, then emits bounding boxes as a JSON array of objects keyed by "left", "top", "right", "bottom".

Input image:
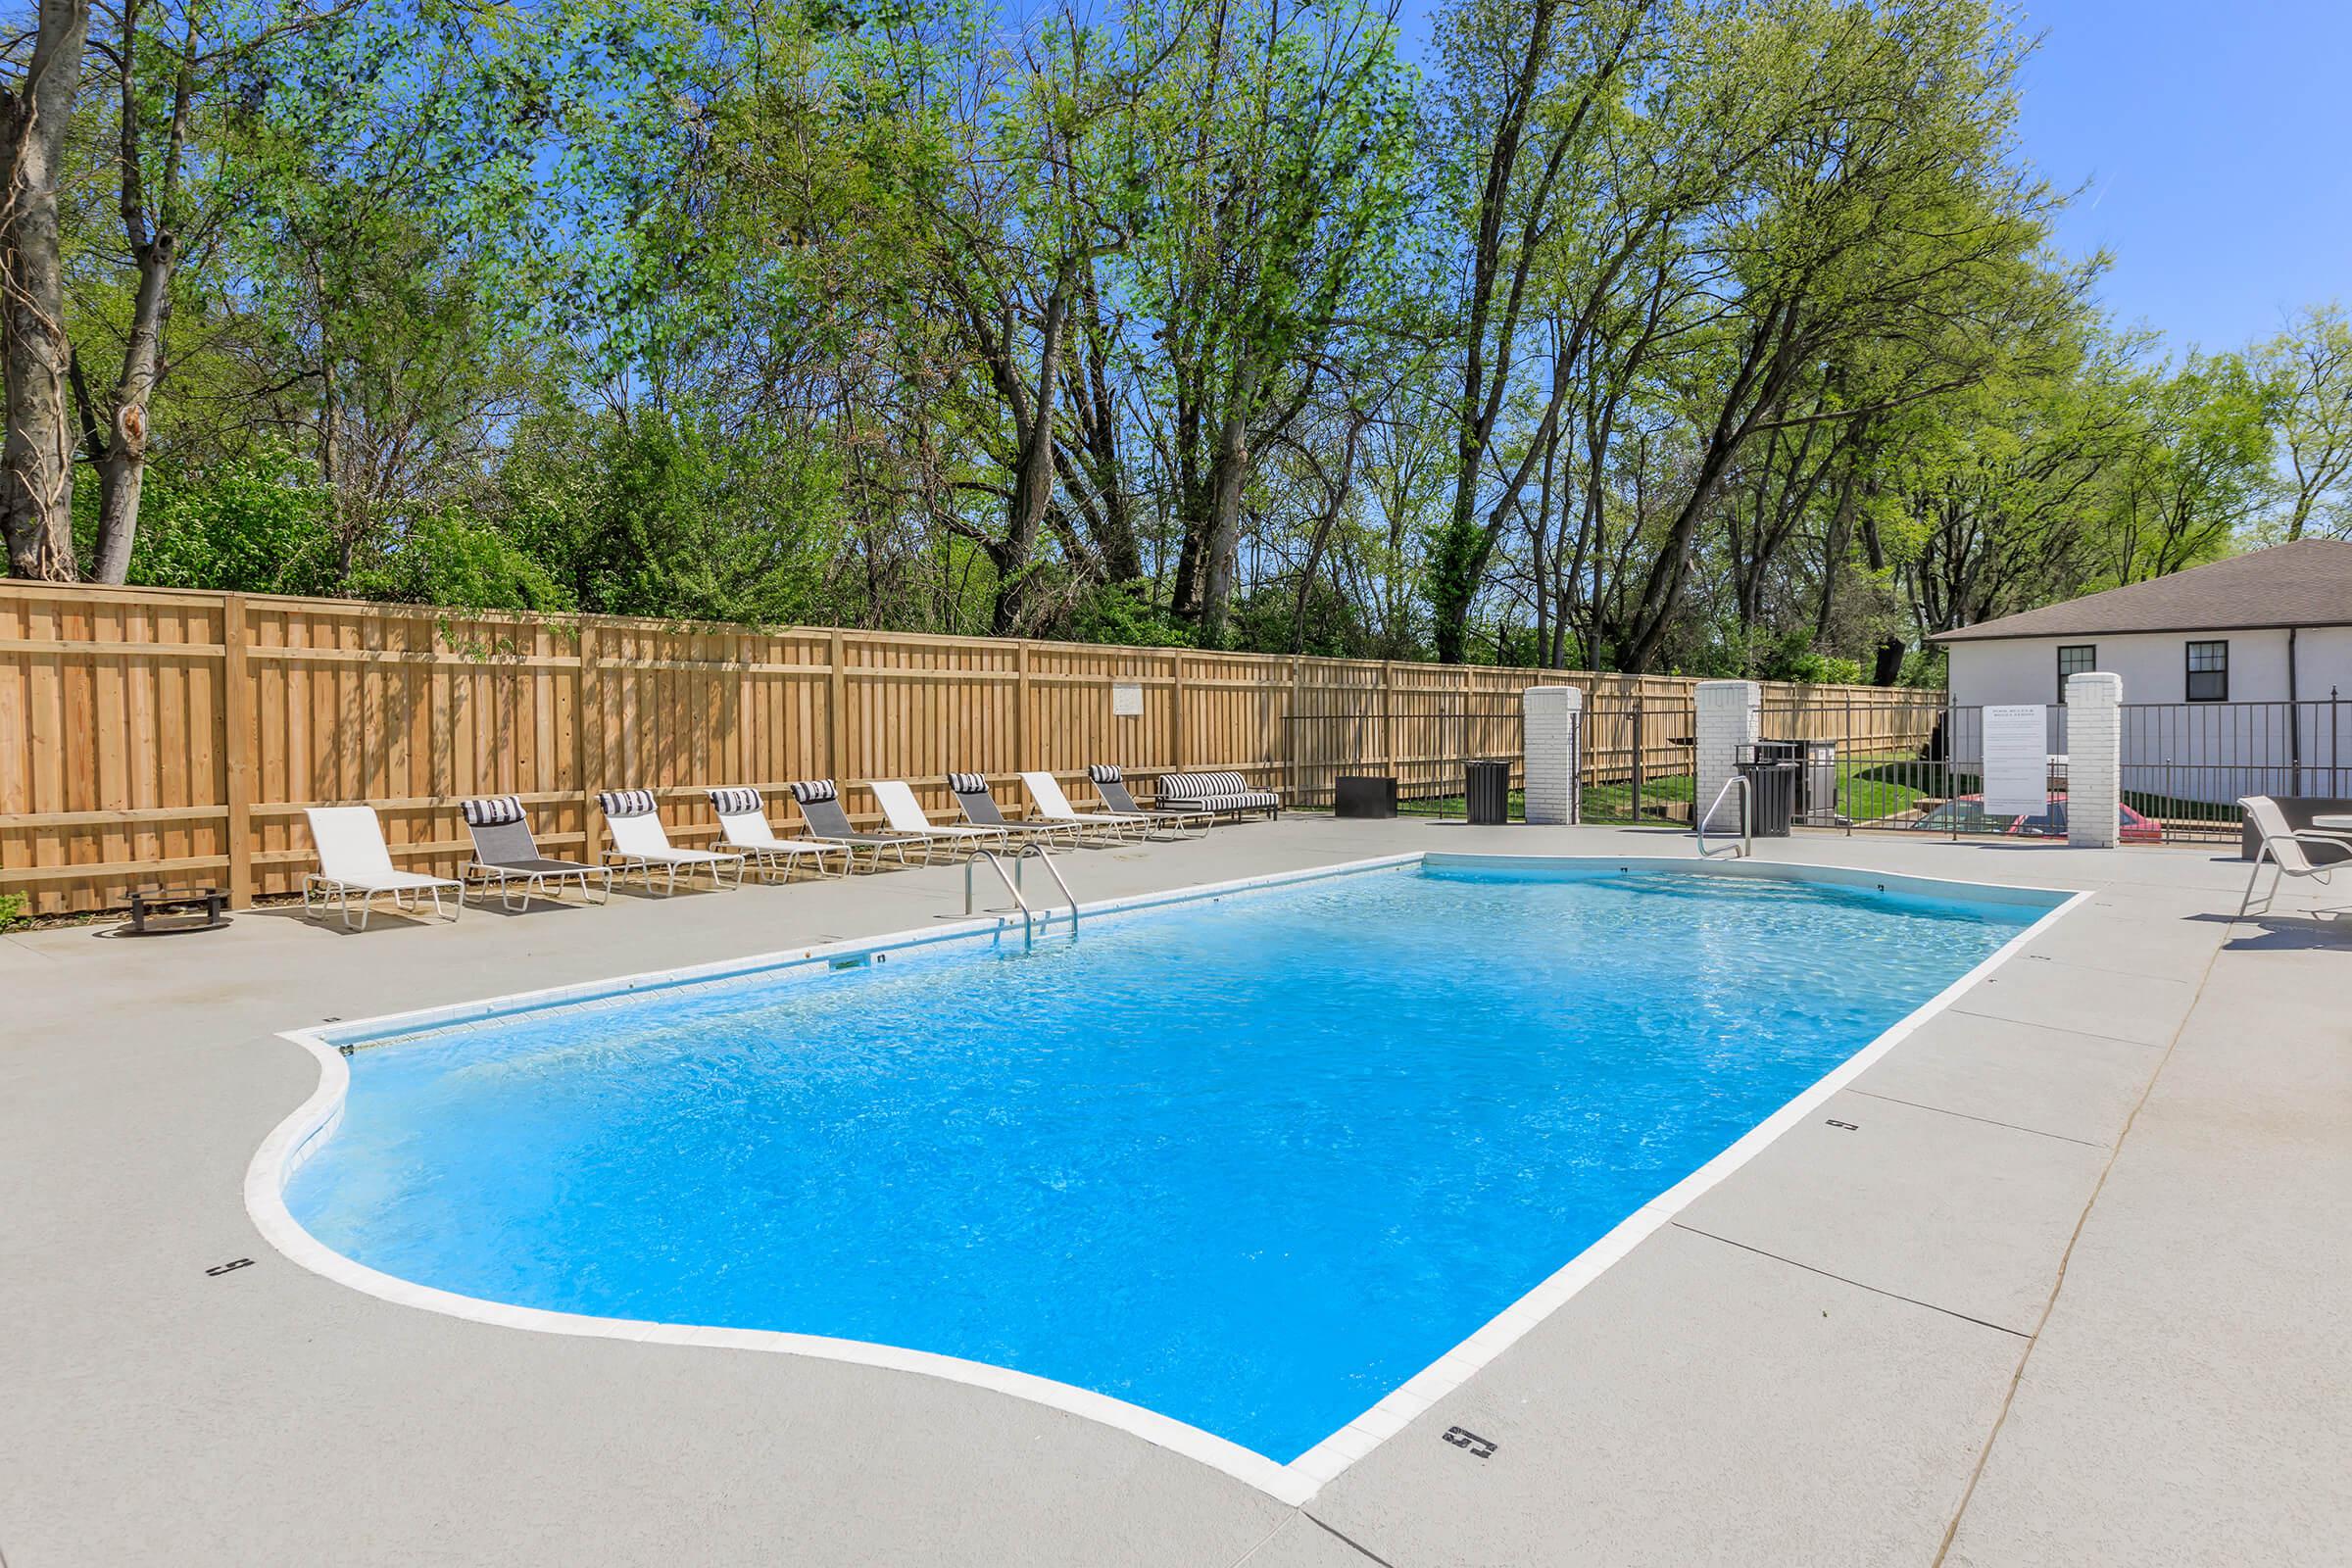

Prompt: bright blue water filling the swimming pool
[{"left": 287, "top": 865, "right": 2048, "bottom": 1462}]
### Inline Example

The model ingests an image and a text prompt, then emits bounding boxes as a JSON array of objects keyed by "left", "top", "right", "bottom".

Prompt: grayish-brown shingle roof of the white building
[{"left": 1929, "top": 538, "right": 2352, "bottom": 642}]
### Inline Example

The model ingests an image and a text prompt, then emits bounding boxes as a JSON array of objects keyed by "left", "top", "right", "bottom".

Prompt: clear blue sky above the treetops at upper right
[{"left": 1404, "top": 0, "right": 2352, "bottom": 350}]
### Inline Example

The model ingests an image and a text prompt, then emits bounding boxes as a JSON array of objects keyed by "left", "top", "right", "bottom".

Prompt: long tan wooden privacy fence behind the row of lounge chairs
[{"left": 0, "top": 581, "right": 1915, "bottom": 914}]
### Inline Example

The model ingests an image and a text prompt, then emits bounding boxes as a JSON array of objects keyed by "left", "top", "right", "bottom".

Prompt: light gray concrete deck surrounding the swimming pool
[{"left": 0, "top": 818, "right": 2352, "bottom": 1568}]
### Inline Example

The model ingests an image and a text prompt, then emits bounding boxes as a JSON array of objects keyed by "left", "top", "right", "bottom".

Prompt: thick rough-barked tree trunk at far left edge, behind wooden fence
[{"left": 0, "top": 0, "right": 89, "bottom": 583}]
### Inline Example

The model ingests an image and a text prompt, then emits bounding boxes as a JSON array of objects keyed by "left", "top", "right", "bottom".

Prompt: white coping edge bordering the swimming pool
[{"left": 245, "top": 851, "right": 2091, "bottom": 1507}]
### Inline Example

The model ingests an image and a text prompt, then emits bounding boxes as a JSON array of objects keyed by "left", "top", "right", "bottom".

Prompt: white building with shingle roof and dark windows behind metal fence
[{"left": 1936, "top": 538, "right": 2352, "bottom": 802}]
